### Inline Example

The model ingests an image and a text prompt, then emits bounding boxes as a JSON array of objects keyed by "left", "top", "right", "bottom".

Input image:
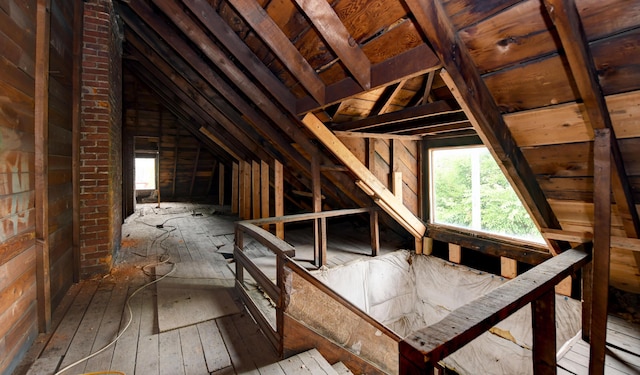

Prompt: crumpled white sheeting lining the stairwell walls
[{"left": 315, "top": 250, "right": 581, "bottom": 374}]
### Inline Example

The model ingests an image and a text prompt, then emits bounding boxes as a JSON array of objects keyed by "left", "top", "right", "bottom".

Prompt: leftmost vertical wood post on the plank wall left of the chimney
[{"left": 34, "top": 0, "right": 51, "bottom": 332}]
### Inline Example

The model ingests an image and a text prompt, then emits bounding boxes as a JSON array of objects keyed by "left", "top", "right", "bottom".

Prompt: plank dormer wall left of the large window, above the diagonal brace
[{"left": 338, "top": 133, "right": 421, "bottom": 217}]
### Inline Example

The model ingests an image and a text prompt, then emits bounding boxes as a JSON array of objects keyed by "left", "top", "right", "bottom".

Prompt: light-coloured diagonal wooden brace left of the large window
[{"left": 302, "top": 113, "right": 426, "bottom": 238}]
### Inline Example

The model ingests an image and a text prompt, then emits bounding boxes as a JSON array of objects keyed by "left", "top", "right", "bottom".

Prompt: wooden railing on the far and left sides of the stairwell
[{"left": 234, "top": 207, "right": 386, "bottom": 354}]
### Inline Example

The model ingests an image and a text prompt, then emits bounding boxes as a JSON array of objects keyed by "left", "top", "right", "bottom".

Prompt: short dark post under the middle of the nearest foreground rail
[{"left": 531, "top": 289, "right": 556, "bottom": 375}]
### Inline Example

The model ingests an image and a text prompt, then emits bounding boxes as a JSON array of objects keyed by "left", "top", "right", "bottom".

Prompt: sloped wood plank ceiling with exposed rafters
[{"left": 120, "top": 0, "right": 640, "bottom": 286}]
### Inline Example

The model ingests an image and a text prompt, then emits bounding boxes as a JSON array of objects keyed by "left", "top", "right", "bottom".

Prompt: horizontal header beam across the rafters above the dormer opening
[{"left": 296, "top": 44, "right": 441, "bottom": 115}]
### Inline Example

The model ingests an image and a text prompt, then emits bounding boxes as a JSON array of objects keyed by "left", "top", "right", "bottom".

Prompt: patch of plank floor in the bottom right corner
[{"left": 558, "top": 315, "right": 640, "bottom": 375}]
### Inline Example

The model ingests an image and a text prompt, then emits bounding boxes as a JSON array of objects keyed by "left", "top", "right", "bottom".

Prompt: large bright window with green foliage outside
[{"left": 429, "top": 146, "right": 544, "bottom": 243}]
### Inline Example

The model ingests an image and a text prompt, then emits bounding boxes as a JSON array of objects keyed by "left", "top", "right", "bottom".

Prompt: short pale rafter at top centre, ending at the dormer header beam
[{"left": 295, "top": 0, "right": 371, "bottom": 91}]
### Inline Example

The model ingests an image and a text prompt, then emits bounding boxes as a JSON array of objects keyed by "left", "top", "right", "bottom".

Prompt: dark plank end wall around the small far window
[{"left": 123, "top": 69, "right": 226, "bottom": 204}]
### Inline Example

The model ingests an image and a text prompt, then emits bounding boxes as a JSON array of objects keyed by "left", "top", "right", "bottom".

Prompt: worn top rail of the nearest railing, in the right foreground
[{"left": 400, "top": 243, "right": 591, "bottom": 373}]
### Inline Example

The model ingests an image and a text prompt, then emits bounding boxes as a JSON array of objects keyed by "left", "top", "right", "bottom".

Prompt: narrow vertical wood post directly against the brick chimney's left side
[{"left": 71, "top": 1, "right": 84, "bottom": 283}]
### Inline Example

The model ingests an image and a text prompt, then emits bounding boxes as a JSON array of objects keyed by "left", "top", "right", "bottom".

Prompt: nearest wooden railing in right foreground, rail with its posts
[{"left": 400, "top": 243, "right": 591, "bottom": 375}]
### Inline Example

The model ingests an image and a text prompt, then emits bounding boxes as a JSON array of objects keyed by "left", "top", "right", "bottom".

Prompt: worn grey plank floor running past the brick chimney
[{"left": 14, "top": 203, "right": 399, "bottom": 375}]
